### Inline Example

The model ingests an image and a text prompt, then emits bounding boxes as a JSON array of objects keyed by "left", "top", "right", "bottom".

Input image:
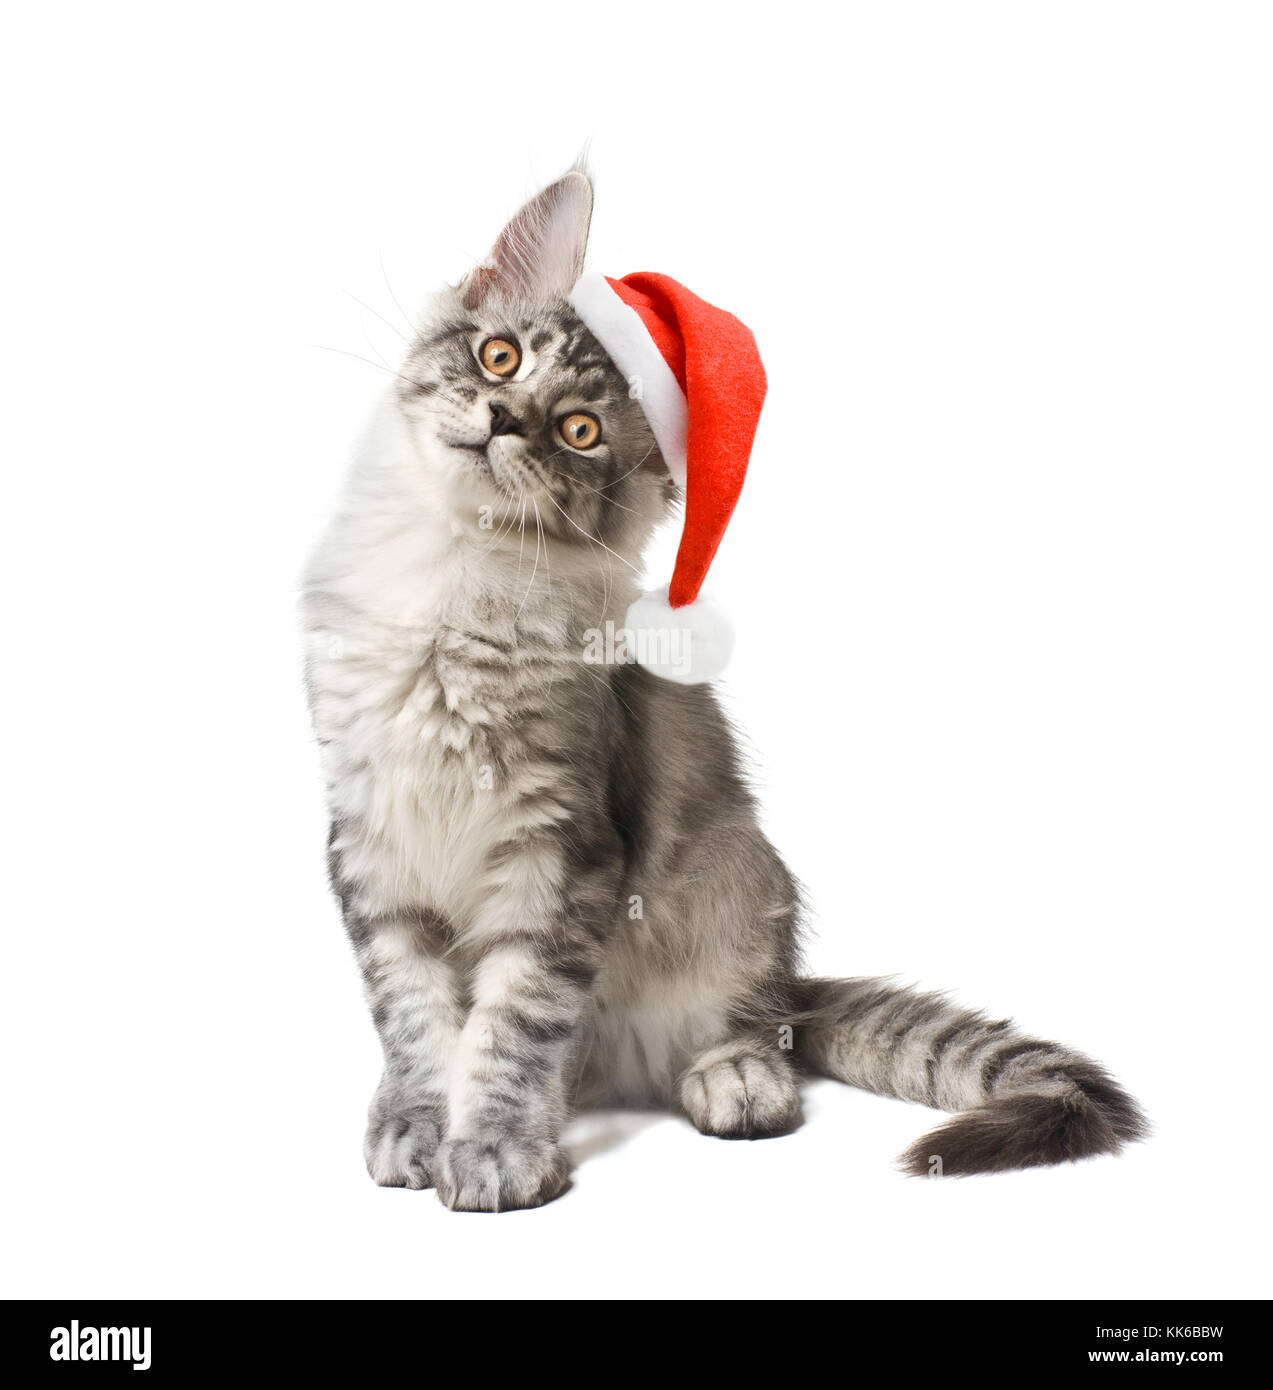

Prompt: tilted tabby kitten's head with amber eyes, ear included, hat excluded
[{"left": 396, "top": 171, "right": 674, "bottom": 553}]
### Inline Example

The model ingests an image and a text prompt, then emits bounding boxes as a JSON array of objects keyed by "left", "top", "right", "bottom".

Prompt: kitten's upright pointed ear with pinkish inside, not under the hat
[{"left": 460, "top": 170, "right": 592, "bottom": 309}]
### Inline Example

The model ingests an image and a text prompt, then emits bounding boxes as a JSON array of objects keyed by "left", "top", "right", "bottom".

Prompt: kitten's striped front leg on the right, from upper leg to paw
[{"left": 435, "top": 844, "right": 618, "bottom": 1212}]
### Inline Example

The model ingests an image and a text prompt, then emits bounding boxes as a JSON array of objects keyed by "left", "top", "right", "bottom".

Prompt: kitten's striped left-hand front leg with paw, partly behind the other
[{"left": 349, "top": 912, "right": 463, "bottom": 1188}]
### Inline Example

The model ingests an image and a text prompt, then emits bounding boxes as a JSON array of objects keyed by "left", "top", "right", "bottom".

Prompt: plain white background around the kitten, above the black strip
[{"left": 0, "top": 3, "right": 1273, "bottom": 1298}]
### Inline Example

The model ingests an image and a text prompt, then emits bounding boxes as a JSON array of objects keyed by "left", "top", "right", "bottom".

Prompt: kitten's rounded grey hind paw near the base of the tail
[{"left": 678, "top": 1030, "right": 800, "bottom": 1138}]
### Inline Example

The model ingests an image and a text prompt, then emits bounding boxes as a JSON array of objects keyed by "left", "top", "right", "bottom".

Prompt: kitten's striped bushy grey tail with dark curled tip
[{"left": 798, "top": 979, "right": 1149, "bottom": 1177}]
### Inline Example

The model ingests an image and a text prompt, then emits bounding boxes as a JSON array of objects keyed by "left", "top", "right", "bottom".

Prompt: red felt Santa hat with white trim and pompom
[{"left": 570, "top": 271, "right": 764, "bottom": 684}]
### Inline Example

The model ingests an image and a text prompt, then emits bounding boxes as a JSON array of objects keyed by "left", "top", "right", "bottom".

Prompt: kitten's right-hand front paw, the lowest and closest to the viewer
[{"left": 434, "top": 1134, "right": 570, "bottom": 1212}]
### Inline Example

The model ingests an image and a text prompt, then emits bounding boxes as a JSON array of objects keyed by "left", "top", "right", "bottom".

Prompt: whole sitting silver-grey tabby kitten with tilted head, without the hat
[{"left": 303, "top": 171, "right": 1145, "bottom": 1211}]
